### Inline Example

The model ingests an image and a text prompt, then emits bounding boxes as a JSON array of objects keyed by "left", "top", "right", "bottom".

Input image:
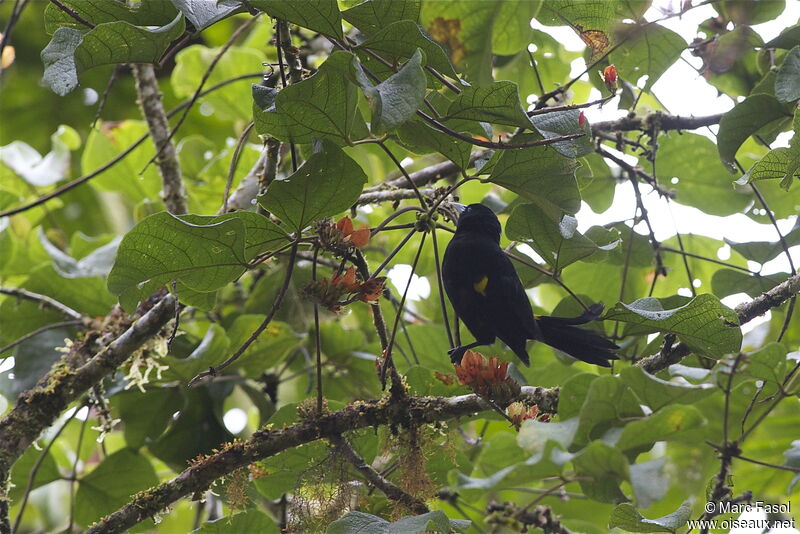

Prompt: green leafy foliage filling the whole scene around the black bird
[{"left": 0, "top": 0, "right": 800, "bottom": 532}]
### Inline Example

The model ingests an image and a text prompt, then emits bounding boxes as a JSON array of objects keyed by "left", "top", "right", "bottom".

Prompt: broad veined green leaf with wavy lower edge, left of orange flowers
[{"left": 108, "top": 212, "right": 247, "bottom": 310}]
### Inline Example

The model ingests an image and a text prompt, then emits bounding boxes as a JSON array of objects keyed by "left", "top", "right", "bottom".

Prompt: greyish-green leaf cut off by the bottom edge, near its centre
[{"left": 325, "top": 510, "right": 472, "bottom": 534}]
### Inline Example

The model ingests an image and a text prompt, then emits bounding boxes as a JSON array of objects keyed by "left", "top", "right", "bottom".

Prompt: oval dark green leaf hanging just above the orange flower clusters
[{"left": 259, "top": 142, "right": 367, "bottom": 231}]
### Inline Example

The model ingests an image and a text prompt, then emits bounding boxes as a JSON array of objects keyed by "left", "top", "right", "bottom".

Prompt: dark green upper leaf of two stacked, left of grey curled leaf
[{"left": 254, "top": 51, "right": 367, "bottom": 145}]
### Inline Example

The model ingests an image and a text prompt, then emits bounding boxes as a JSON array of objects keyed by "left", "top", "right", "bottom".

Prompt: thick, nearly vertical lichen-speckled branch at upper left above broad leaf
[{"left": 133, "top": 64, "right": 189, "bottom": 215}]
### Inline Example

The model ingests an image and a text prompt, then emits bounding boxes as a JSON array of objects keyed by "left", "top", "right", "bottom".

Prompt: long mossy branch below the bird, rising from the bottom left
[{"left": 87, "top": 386, "right": 558, "bottom": 534}]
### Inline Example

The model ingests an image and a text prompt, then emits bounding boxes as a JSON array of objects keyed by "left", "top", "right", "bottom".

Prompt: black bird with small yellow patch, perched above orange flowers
[{"left": 442, "top": 204, "right": 619, "bottom": 367}]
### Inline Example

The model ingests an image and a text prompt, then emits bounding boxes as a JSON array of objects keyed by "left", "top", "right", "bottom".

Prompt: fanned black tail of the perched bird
[{"left": 536, "top": 304, "right": 619, "bottom": 367}]
